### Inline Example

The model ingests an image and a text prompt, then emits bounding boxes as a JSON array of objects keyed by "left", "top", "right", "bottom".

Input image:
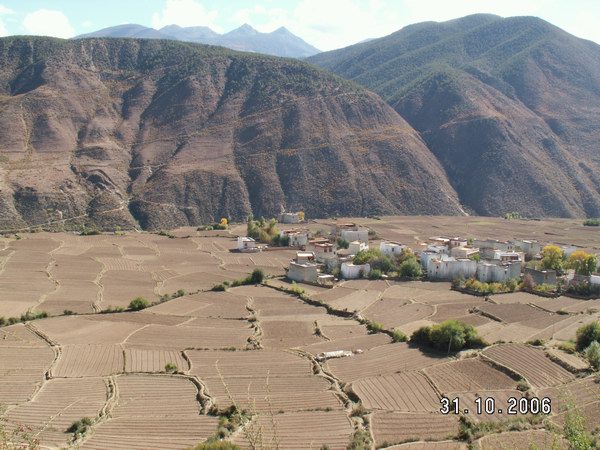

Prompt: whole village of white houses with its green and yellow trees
[{"left": 237, "top": 212, "right": 600, "bottom": 298}]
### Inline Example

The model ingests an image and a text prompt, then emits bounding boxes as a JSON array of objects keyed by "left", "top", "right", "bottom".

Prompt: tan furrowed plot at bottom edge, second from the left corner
[{"left": 81, "top": 375, "right": 218, "bottom": 450}]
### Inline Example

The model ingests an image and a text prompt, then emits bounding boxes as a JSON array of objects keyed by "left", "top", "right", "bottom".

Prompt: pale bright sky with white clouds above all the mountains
[{"left": 0, "top": 0, "right": 600, "bottom": 50}]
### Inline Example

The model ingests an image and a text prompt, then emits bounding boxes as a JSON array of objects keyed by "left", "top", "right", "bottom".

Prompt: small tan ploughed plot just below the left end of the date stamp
[{"left": 371, "top": 412, "right": 458, "bottom": 445}]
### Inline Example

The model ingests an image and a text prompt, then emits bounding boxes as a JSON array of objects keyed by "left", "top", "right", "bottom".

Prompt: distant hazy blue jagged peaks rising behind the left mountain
[{"left": 74, "top": 24, "right": 319, "bottom": 58}]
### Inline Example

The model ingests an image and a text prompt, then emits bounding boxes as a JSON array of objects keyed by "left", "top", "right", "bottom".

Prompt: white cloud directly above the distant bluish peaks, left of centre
[{"left": 152, "top": 0, "right": 221, "bottom": 32}]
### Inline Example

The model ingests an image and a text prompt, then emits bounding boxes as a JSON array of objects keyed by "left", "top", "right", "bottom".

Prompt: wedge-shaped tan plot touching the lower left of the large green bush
[{"left": 327, "top": 343, "right": 446, "bottom": 382}]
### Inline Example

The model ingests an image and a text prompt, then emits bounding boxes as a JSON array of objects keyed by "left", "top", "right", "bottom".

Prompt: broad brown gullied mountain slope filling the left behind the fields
[{"left": 0, "top": 37, "right": 461, "bottom": 230}]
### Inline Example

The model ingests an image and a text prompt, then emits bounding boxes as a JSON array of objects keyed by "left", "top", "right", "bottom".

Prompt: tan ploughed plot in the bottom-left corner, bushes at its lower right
[{"left": 6, "top": 378, "right": 108, "bottom": 448}]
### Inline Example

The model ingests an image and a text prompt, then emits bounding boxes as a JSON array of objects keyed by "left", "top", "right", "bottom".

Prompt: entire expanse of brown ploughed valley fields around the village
[{"left": 0, "top": 218, "right": 600, "bottom": 450}]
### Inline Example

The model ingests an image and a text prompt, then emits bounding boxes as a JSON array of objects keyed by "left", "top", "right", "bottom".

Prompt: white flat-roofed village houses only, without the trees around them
[{"left": 238, "top": 221, "right": 600, "bottom": 285}]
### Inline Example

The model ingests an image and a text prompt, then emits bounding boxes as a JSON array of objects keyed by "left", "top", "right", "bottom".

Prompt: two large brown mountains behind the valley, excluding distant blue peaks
[{"left": 0, "top": 15, "right": 600, "bottom": 229}]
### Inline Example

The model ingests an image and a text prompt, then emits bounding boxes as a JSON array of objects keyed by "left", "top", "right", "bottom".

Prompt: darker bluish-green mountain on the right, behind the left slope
[{"left": 309, "top": 15, "right": 600, "bottom": 217}]
